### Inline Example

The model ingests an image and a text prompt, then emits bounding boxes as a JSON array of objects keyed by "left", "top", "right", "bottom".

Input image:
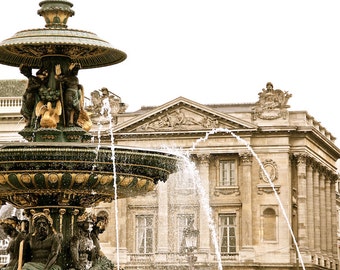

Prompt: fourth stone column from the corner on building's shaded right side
[{"left": 320, "top": 171, "right": 327, "bottom": 253}]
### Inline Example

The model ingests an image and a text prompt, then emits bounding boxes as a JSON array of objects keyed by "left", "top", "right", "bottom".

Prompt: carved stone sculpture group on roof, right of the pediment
[{"left": 252, "top": 82, "right": 292, "bottom": 120}]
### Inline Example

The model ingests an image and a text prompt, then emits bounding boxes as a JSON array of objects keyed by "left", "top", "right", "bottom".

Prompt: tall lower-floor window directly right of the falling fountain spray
[{"left": 219, "top": 214, "right": 236, "bottom": 256}]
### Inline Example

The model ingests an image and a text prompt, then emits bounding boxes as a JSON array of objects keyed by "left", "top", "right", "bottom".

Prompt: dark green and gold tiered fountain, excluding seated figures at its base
[{"left": 0, "top": 0, "right": 178, "bottom": 269}]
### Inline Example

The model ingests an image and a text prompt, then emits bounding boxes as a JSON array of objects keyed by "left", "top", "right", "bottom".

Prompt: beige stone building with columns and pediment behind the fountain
[{"left": 0, "top": 79, "right": 340, "bottom": 270}]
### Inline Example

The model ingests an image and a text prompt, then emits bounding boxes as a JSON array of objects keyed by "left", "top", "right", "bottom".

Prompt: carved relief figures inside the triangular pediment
[{"left": 136, "top": 108, "right": 223, "bottom": 131}]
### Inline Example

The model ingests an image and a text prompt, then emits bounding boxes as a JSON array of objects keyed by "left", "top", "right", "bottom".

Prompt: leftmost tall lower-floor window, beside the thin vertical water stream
[{"left": 136, "top": 216, "right": 153, "bottom": 253}]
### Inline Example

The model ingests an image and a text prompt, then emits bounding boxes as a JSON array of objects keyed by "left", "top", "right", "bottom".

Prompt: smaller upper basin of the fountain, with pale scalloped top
[{"left": 0, "top": 28, "right": 127, "bottom": 69}]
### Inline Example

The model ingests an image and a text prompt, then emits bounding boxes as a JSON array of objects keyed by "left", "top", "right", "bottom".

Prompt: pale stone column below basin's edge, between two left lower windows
[{"left": 156, "top": 182, "right": 169, "bottom": 253}]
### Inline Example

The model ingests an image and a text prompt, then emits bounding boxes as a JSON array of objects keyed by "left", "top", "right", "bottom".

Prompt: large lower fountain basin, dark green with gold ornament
[{"left": 0, "top": 142, "right": 179, "bottom": 209}]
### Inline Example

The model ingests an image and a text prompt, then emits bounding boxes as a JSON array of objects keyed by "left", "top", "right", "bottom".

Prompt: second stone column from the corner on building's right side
[{"left": 306, "top": 159, "right": 315, "bottom": 251}]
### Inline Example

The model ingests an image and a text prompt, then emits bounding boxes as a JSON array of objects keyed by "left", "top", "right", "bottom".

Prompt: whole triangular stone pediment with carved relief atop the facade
[{"left": 114, "top": 97, "right": 256, "bottom": 134}]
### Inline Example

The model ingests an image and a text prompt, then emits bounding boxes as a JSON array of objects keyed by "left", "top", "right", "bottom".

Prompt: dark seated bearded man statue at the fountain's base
[{"left": 22, "top": 213, "right": 62, "bottom": 270}]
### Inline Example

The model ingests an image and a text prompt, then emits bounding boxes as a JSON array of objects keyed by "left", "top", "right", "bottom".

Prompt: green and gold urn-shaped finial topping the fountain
[{"left": 38, "top": 0, "right": 74, "bottom": 28}]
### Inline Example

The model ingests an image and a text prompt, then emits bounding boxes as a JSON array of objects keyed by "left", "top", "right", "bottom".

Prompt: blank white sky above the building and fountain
[{"left": 0, "top": 0, "right": 340, "bottom": 148}]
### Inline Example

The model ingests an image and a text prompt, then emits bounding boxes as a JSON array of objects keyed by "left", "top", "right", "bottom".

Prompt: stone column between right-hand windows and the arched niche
[{"left": 238, "top": 152, "right": 255, "bottom": 261}]
